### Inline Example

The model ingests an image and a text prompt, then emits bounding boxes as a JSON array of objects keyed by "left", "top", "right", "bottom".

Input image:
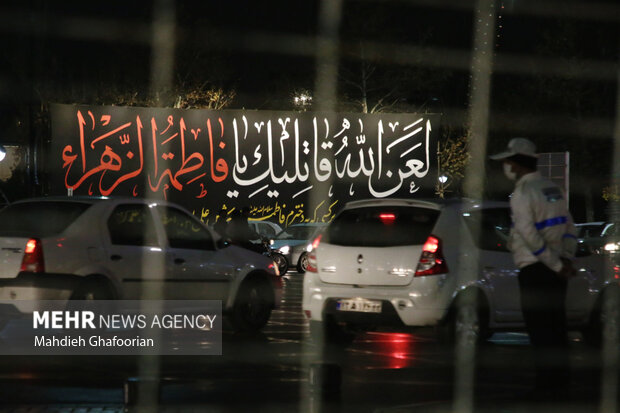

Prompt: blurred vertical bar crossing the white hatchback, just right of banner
[{"left": 453, "top": 0, "right": 496, "bottom": 413}]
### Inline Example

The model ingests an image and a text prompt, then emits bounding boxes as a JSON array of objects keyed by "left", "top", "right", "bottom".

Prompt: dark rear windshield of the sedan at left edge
[{"left": 0, "top": 201, "right": 91, "bottom": 237}]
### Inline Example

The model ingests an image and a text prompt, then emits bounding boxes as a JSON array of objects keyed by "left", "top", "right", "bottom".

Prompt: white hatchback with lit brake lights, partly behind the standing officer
[{"left": 303, "top": 199, "right": 618, "bottom": 341}]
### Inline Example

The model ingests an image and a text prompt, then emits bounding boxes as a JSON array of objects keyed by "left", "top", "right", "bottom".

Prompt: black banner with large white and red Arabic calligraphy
[{"left": 49, "top": 105, "right": 439, "bottom": 226}]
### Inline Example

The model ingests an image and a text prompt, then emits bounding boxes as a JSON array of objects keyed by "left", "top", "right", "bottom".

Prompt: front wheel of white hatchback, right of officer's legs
[{"left": 581, "top": 287, "right": 620, "bottom": 347}]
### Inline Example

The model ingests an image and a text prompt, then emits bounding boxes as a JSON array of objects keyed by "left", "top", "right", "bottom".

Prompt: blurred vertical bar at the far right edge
[{"left": 600, "top": 59, "right": 620, "bottom": 413}]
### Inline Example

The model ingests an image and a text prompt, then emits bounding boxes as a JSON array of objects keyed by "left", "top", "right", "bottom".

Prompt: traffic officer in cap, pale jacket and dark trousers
[{"left": 491, "top": 138, "right": 577, "bottom": 399}]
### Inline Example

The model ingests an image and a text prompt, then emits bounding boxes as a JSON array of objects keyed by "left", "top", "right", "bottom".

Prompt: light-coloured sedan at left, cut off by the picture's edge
[{"left": 0, "top": 197, "right": 282, "bottom": 331}]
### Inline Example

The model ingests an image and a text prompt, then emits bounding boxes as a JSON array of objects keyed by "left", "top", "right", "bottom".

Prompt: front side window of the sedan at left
[{"left": 157, "top": 206, "right": 215, "bottom": 250}]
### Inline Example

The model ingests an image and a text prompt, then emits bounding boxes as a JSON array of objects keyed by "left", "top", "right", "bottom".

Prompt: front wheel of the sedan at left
[{"left": 232, "top": 278, "right": 274, "bottom": 333}]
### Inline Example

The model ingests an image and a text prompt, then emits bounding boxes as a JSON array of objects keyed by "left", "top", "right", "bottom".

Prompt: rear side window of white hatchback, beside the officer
[{"left": 463, "top": 208, "right": 512, "bottom": 252}]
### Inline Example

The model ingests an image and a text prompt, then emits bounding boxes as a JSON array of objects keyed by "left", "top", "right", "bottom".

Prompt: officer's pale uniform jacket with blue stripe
[{"left": 508, "top": 172, "right": 577, "bottom": 272}]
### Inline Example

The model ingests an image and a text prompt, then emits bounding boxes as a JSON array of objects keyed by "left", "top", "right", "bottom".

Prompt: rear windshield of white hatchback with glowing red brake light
[{"left": 325, "top": 206, "right": 439, "bottom": 247}]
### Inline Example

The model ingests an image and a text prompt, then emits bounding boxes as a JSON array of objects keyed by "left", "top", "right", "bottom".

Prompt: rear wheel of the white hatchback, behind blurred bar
[{"left": 439, "top": 292, "right": 491, "bottom": 345}]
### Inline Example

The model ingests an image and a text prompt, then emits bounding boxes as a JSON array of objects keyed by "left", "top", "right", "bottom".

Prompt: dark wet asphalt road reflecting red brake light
[{"left": 0, "top": 273, "right": 617, "bottom": 413}]
